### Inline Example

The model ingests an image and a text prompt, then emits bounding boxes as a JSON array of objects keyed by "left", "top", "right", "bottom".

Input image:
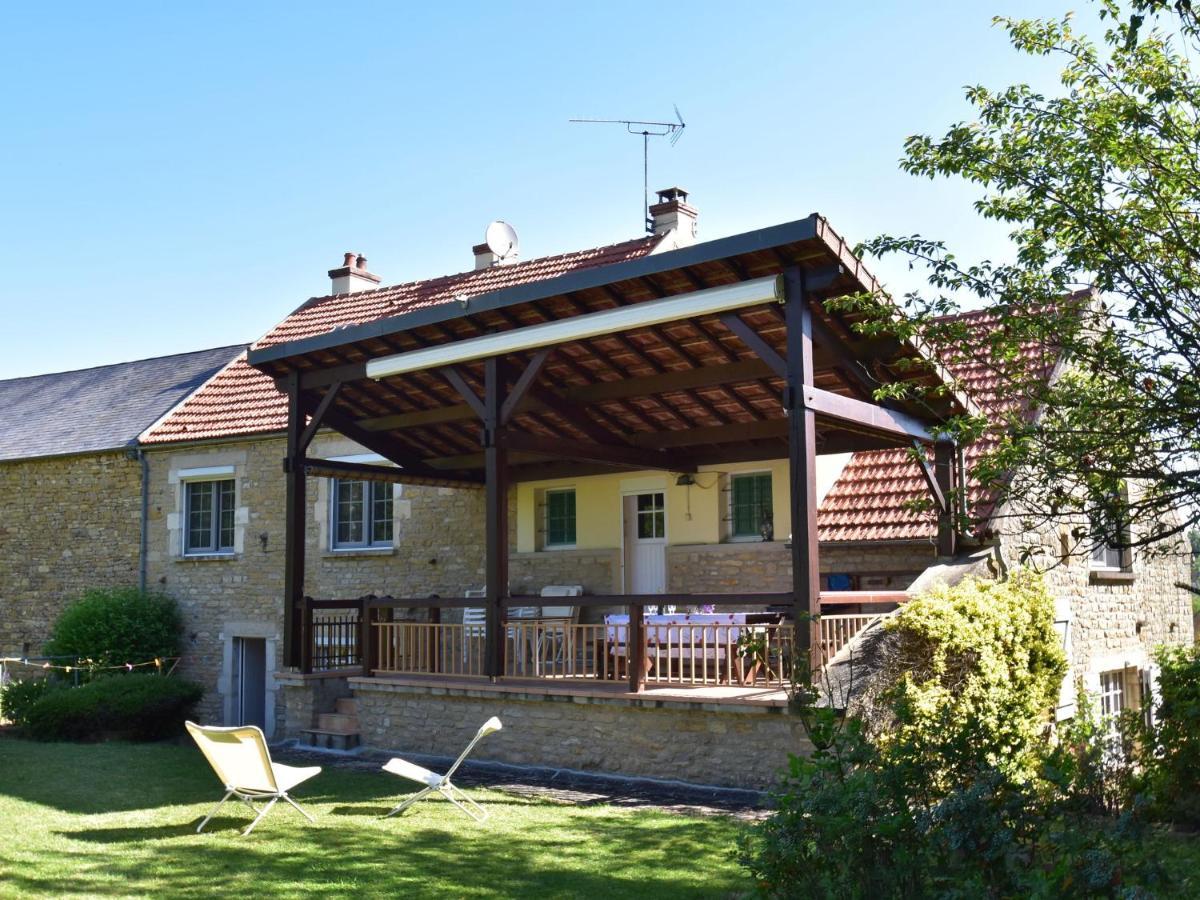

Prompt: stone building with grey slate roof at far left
[{"left": 0, "top": 347, "right": 242, "bottom": 655}]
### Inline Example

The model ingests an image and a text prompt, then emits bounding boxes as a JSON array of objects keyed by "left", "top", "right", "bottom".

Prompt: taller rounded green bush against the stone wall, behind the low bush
[{"left": 46, "top": 588, "right": 182, "bottom": 668}]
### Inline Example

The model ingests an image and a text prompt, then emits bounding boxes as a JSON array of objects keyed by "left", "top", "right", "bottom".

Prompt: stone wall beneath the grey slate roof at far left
[{"left": 0, "top": 452, "right": 142, "bottom": 655}]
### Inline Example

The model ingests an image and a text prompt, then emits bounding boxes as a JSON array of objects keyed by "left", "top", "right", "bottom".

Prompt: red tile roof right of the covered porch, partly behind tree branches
[{"left": 817, "top": 312, "right": 1054, "bottom": 541}]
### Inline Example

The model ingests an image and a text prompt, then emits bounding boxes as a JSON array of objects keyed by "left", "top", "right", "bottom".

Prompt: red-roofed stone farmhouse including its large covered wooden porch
[{"left": 119, "top": 188, "right": 1193, "bottom": 785}]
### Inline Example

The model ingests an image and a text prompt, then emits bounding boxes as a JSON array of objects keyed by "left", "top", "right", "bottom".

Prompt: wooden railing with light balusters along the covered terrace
[{"left": 302, "top": 594, "right": 902, "bottom": 688}]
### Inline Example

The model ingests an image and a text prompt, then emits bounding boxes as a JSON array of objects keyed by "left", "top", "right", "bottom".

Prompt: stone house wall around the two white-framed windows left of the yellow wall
[{"left": 145, "top": 436, "right": 484, "bottom": 721}]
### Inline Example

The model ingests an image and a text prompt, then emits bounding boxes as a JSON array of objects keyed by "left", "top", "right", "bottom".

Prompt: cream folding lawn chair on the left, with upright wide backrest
[{"left": 187, "top": 722, "right": 320, "bottom": 835}]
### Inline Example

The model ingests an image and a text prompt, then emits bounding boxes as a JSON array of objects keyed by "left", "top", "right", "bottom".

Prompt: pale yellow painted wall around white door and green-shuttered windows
[{"left": 517, "top": 460, "right": 791, "bottom": 553}]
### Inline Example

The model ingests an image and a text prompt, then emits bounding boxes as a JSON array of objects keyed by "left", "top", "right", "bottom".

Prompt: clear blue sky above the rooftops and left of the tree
[{"left": 0, "top": 0, "right": 1069, "bottom": 378}]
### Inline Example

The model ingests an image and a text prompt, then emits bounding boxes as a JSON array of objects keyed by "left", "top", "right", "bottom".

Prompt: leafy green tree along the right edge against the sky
[{"left": 847, "top": 0, "right": 1200, "bottom": 564}]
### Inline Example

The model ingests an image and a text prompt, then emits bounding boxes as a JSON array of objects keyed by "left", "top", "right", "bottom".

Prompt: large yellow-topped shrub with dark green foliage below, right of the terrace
[{"left": 739, "top": 572, "right": 1160, "bottom": 900}]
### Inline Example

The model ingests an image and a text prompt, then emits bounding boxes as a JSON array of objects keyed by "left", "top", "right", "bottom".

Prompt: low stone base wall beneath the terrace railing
[{"left": 350, "top": 678, "right": 812, "bottom": 788}]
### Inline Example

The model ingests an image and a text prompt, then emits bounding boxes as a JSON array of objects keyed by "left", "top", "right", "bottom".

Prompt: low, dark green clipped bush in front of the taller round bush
[{"left": 25, "top": 673, "right": 204, "bottom": 740}]
